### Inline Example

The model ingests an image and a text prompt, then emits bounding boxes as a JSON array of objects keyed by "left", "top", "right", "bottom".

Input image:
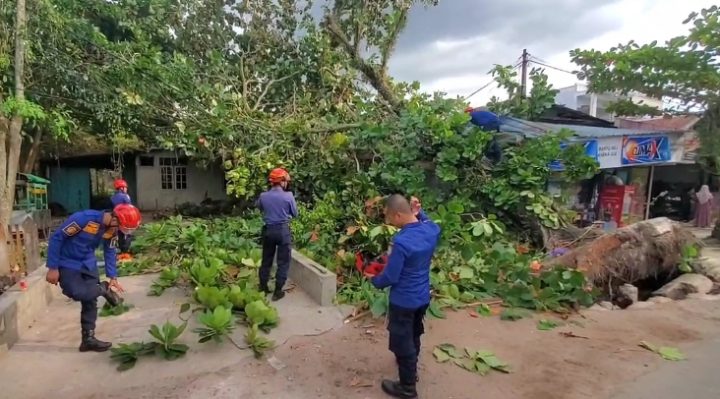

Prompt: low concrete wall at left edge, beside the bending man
[{"left": 0, "top": 265, "right": 60, "bottom": 353}]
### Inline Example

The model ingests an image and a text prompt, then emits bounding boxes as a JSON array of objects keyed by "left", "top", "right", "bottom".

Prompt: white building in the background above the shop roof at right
[{"left": 555, "top": 83, "right": 663, "bottom": 121}]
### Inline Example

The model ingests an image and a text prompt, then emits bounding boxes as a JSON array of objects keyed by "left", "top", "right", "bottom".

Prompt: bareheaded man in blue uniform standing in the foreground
[{"left": 366, "top": 194, "right": 440, "bottom": 399}]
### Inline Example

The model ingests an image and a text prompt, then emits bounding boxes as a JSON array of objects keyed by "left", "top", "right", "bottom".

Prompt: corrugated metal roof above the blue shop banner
[{"left": 500, "top": 116, "right": 676, "bottom": 138}]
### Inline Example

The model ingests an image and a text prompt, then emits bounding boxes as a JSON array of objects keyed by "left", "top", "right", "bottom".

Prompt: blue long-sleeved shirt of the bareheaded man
[{"left": 372, "top": 211, "right": 440, "bottom": 309}]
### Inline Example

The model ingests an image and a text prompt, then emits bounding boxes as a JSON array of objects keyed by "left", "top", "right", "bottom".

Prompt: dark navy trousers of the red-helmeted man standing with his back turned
[{"left": 260, "top": 224, "right": 292, "bottom": 291}]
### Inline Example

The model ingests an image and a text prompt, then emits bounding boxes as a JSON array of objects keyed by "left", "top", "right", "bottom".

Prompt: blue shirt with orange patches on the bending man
[{"left": 47, "top": 210, "right": 117, "bottom": 278}]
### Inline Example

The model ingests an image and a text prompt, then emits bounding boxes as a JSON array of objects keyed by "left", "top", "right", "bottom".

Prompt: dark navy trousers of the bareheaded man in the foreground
[{"left": 388, "top": 304, "right": 428, "bottom": 385}]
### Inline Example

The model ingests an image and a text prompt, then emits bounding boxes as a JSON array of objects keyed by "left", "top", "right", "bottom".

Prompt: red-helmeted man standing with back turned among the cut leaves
[{"left": 256, "top": 168, "right": 298, "bottom": 301}]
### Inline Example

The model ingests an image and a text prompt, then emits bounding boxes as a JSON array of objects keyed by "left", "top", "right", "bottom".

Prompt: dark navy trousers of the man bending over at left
[{"left": 60, "top": 267, "right": 102, "bottom": 331}]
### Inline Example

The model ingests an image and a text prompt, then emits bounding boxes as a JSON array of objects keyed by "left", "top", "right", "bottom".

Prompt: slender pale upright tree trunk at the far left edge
[{"left": 0, "top": 0, "right": 26, "bottom": 275}]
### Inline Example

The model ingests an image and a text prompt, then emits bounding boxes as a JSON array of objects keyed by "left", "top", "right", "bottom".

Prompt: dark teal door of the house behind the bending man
[{"left": 49, "top": 167, "right": 90, "bottom": 213}]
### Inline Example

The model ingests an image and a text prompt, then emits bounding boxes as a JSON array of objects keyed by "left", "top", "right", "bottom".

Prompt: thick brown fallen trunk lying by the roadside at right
[{"left": 546, "top": 218, "right": 697, "bottom": 294}]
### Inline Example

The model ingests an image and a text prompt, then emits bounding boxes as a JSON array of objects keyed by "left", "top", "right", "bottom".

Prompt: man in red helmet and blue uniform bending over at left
[{"left": 45, "top": 204, "right": 141, "bottom": 352}]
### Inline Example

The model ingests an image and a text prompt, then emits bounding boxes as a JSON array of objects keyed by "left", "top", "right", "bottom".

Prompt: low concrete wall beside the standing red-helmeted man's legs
[{"left": 288, "top": 249, "right": 337, "bottom": 306}]
